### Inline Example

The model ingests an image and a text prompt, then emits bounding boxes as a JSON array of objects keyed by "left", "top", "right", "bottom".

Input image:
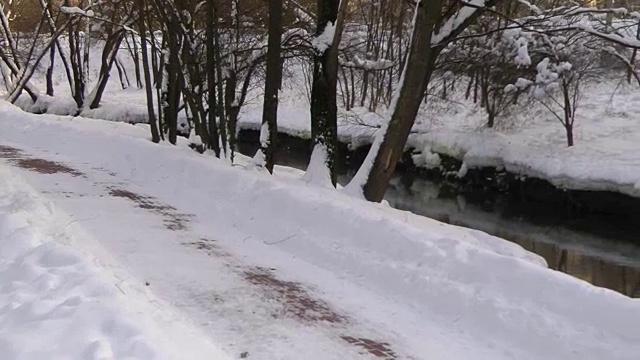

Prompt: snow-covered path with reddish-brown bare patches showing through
[{"left": 0, "top": 145, "right": 394, "bottom": 359}]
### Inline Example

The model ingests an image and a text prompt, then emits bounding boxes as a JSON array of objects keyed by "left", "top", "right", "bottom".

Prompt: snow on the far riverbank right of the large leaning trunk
[{"left": 410, "top": 83, "right": 640, "bottom": 197}]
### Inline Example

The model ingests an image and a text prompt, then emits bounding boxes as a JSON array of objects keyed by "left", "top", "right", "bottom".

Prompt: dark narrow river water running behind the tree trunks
[{"left": 239, "top": 139, "right": 640, "bottom": 298}]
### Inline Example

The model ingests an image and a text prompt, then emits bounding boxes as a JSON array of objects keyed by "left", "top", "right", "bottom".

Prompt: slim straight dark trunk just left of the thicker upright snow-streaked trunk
[{"left": 260, "top": 0, "right": 282, "bottom": 173}]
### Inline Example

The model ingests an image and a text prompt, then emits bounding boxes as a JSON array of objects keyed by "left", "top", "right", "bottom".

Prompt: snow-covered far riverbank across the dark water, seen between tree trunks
[{"left": 240, "top": 82, "right": 640, "bottom": 197}]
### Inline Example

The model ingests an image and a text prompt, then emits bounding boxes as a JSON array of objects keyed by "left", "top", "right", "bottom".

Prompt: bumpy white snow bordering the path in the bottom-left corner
[{"left": 0, "top": 164, "right": 227, "bottom": 360}]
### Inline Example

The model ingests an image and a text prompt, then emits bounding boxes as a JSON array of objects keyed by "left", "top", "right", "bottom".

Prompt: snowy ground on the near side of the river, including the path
[{"left": 0, "top": 102, "right": 640, "bottom": 360}]
